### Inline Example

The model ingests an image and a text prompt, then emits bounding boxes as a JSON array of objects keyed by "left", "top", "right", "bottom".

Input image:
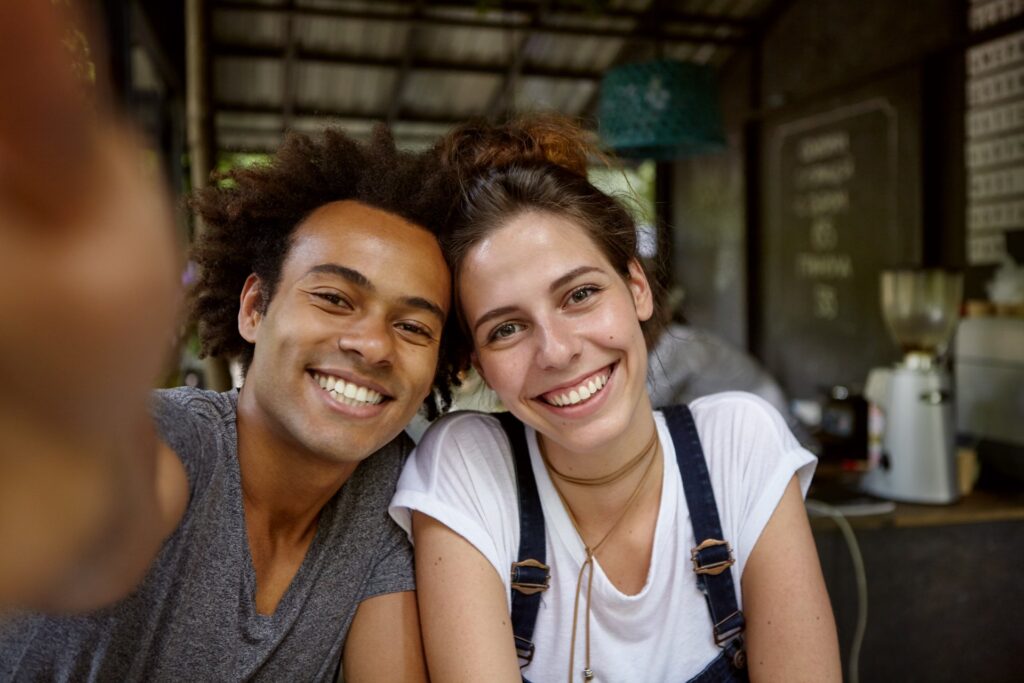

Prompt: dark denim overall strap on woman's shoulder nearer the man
[{"left": 495, "top": 413, "right": 551, "bottom": 667}]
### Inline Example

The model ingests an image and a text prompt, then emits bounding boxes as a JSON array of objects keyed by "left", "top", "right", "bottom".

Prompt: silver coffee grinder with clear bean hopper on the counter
[{"left": 861, "top": 268, "right": 963, "bottom": 505}]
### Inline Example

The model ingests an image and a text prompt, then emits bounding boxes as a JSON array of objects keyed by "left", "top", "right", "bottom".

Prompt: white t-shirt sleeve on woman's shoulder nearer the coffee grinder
[{"left": 690, "top": 391, "right": 817, "bottom": 575}]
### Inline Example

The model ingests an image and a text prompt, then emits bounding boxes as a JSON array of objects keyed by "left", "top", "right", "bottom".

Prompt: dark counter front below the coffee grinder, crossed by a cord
[{"left": 814, "top": 521, "right": 1024, "bottom": 683}]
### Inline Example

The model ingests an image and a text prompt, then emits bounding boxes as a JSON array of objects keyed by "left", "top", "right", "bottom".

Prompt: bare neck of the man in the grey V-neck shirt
[{"left": 238, "top": 389, "right": 357, "bottom": 542}]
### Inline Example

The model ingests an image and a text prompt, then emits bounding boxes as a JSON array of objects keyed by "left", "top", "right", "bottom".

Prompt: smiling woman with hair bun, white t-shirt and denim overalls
[{"left": 391, "top": 118, "right": 841, "bottom": 683}]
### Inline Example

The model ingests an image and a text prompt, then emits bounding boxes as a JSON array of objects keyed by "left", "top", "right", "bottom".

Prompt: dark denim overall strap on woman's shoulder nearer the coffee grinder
[{"left": 662, "top": 405, "right": 746, "bottom": 669}]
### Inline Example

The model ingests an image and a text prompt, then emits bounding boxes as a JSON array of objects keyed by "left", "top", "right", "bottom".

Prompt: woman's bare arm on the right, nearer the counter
[{"left": 742, "top": 477, "right": 843, "bottom": 683}]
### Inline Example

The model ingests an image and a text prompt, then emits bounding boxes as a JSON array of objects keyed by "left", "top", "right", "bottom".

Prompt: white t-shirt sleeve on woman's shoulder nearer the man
[{"left": 390, "top": 412, "right": 519, "bottom": 583}]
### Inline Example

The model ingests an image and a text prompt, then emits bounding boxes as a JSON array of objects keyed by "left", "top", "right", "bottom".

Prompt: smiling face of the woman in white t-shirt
[{"left": 458, "top": 212, "right": 652, "bottom": 452}]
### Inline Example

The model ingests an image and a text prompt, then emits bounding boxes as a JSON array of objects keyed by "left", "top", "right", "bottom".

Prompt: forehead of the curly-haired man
[{"left": 283, "top": 200, "right": 449, "bottom": 306}]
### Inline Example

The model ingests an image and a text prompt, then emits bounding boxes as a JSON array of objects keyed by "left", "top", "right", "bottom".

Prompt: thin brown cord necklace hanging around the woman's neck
[{"left": 539, "top": 426, "right": 660, "bottom": 683}]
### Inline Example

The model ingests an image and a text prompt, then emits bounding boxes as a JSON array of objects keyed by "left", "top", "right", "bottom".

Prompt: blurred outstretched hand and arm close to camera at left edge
[{"left": 0, "top": 0, "right": 186, "bottom": 609}]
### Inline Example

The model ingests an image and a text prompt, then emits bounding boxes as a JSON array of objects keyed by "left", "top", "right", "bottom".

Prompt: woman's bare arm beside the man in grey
[{"left": 413, "top": 512, "right": 521, "bottom": 683}]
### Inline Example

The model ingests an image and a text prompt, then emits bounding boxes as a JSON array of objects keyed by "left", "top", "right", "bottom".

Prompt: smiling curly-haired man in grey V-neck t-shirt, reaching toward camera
[{"left": 0, "top": 9, "right": 451, "bottom": 682}]
